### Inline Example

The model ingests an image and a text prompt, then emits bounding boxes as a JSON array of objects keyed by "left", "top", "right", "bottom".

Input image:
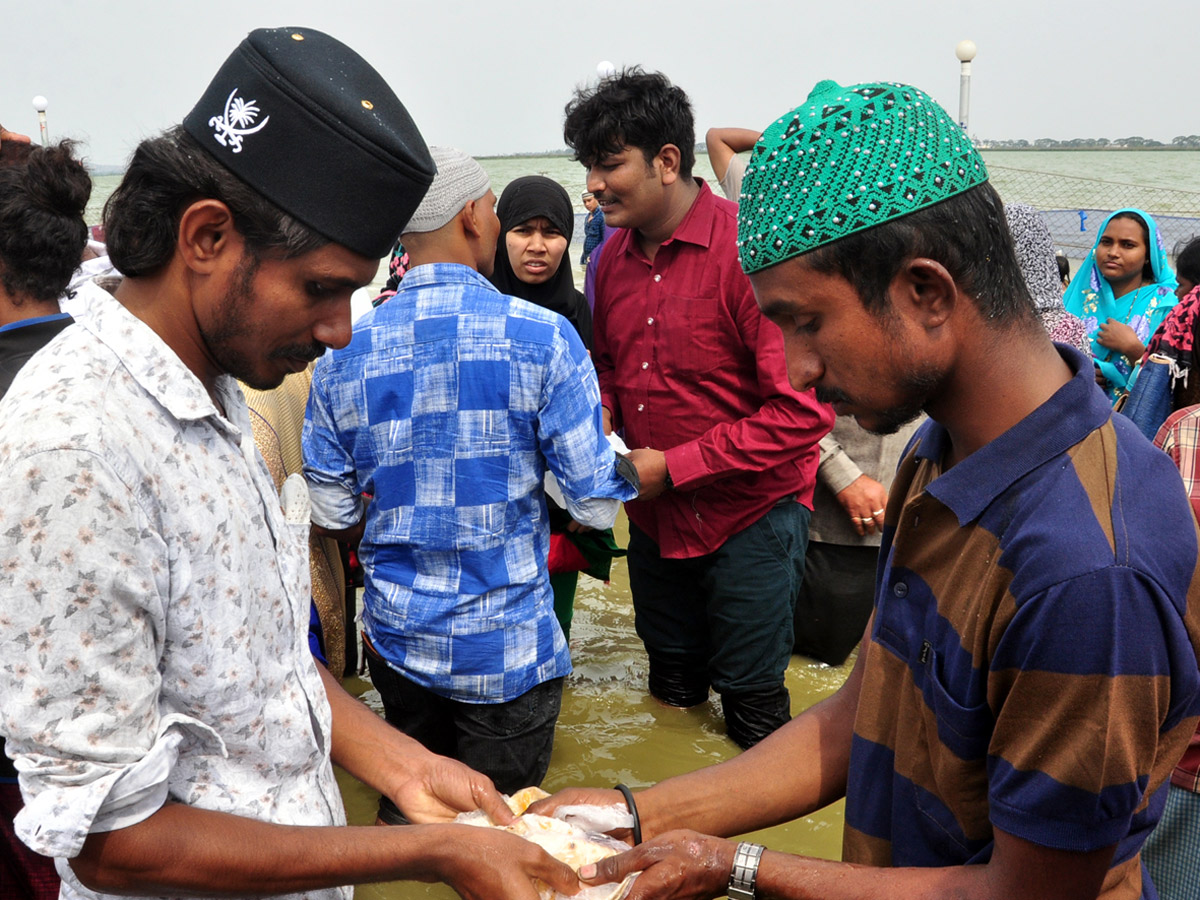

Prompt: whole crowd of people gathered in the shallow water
[{"left": 0, "top": 19, "right": 1200, "bottom": 900}]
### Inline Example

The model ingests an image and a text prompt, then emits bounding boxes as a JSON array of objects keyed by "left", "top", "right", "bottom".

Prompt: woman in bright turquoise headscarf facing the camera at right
[{"left": 1062, "top": 209, "right": 1176, "bottom": 400}]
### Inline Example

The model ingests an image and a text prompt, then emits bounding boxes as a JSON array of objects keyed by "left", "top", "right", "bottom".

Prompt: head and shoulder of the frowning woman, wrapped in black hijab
[{"left": 492, "top": 175, "right": 592, "bottom": 350}]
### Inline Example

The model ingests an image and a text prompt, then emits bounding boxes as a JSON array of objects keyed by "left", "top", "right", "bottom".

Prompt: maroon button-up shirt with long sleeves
[{"left": 593, "top": 181, "right": 834, "bottom": 559}]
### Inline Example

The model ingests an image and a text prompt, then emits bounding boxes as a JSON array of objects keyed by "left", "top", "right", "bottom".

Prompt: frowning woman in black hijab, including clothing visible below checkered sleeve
[{"left": 492, "top": 175, "right": 625, "bottom": 638}]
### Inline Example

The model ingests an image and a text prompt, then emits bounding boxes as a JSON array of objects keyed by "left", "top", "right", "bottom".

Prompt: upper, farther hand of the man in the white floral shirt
[{"left": 388, "top": 748, "right": 514, "bottom": 824}]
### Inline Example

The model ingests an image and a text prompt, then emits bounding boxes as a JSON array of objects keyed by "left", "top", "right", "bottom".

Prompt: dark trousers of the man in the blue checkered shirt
[{"left": 364, "top": 642, "right": 563, "bottom": 821}]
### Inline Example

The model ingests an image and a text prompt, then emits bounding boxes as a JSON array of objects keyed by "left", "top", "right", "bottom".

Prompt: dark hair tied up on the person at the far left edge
[{"left": 0, "top": 140, "right": 91, "bottom": 302}]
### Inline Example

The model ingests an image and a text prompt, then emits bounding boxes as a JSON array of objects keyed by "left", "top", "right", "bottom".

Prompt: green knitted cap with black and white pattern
[{"left": 738, "top": 82, "right": 988, "bottom": 275}]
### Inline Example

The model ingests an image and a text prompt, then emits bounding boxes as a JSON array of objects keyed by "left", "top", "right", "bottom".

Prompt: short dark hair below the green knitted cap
[{"left": 803, "top": 184, "right": 1037, "bottom": 324}]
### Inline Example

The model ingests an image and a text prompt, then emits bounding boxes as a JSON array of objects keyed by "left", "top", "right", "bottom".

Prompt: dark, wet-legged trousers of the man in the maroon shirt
[{"left": 629, "top": 502, "right": 811, "bottom": 746}]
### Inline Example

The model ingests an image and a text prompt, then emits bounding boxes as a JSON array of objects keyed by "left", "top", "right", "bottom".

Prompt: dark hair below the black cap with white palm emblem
[{"left": 104, "top": 126, "right": 329, "bottom": 277}]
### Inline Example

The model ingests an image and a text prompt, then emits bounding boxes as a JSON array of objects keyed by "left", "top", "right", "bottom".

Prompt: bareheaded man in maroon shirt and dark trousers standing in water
[{"left": 564, "top": 68, "right": 833, "bottom": 748}]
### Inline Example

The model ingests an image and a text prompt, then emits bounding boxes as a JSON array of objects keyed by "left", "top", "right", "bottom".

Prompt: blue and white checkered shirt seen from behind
[{"left": 304, "top": 264, "right": 636, "bottom": 703}]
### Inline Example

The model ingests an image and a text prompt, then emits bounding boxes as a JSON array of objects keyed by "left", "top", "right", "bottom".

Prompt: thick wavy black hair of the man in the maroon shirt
[{"left": 563, "top": 66, "right": 696, "bottom": 178}]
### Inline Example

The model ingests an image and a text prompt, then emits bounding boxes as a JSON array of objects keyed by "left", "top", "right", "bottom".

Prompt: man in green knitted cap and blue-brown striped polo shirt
[{"left": 535, "top": 83, "right": 1200, "bottom": 900}]
